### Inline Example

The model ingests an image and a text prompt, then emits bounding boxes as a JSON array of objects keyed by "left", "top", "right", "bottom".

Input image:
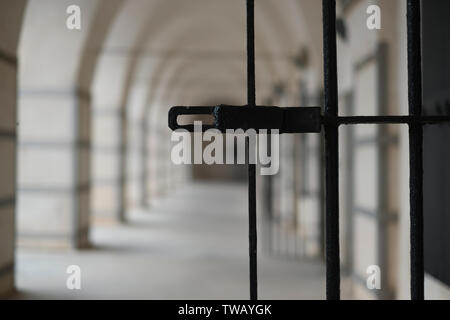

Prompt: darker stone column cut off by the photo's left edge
[{"left": 0, "top": 0, "right": 26, "bottom": 297}]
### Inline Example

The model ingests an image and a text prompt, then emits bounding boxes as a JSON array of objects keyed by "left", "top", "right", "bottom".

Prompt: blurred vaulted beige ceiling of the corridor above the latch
[{"left": 94, "top": 0, "right": 322, "bottom": 124}]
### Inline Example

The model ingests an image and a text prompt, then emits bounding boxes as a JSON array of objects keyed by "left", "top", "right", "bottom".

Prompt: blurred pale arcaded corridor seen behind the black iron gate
[{"left": 0, "top": 0, "right": 450, "bottom": 299}]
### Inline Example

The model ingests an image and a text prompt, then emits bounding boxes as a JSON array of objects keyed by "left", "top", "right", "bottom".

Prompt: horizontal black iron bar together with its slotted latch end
[{"left": 169, "top": 105, "right": 450, "bottom": 133}]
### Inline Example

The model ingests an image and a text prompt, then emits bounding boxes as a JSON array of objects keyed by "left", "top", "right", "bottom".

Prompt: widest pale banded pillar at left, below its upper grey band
[{"left": 17, "top": 88, "right": 90, "bottom": 248}]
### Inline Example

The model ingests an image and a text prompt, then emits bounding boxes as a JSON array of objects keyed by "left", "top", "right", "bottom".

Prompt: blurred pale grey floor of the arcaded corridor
[{"left": 15, "top": 184, "right": 325, "bottom": 299}]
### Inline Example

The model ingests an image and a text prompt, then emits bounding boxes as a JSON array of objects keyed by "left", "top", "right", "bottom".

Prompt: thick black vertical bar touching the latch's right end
[{"left": 322, "top": 0, "right": 340, "bottom": 300}]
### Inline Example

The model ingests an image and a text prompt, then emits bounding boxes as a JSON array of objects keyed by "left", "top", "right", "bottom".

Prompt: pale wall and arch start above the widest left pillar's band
[{"left": 18, "top": 0, "right": 119, "bottom": 91}]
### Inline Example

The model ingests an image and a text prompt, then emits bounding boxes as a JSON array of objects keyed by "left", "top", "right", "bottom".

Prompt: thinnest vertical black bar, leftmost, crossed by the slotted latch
[{"left": 247, "top": 0, "right": 258, "bottom": 300}]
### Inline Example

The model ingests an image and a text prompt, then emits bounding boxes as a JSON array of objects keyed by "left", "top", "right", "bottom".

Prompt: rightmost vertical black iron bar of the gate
[{"left": 407, "top": 0, "right": 424, "bottom": 300}]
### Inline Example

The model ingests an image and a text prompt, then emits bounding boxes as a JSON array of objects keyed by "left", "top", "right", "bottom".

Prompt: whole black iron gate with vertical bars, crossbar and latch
[{"left": 169, "top": 0, "right": 450, "bottom": 300}]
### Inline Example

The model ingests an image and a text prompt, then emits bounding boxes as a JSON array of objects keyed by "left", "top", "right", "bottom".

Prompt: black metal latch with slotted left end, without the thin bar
[{"left": 169, "top": 105, "right": 322, "bottom": 133}]
